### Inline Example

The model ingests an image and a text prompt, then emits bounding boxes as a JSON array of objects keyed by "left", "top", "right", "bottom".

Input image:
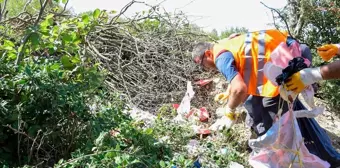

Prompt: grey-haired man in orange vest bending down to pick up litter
[{"left": 192, "top": 29, "right": 312, "bottom": 136}]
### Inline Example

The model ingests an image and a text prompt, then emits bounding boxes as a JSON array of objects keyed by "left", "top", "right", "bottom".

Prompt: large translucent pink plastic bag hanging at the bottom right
[{"left": 249, "top": 105, "right": 330, "bottom": 168}]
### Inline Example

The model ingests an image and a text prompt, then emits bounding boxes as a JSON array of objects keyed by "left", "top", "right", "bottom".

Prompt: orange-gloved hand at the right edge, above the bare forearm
[{"left": 317, "top": 44, "right": 340, "bottom": 61}]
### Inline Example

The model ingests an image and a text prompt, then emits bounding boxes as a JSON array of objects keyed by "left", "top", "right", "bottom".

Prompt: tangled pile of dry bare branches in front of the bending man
[{"left": 88, "top": 1, "right": 220, "bottom": 111}]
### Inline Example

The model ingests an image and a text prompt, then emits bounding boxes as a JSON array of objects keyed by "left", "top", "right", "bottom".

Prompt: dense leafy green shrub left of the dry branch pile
[{"left": 0, "top": 9, "right": 113, "bottom": 166}]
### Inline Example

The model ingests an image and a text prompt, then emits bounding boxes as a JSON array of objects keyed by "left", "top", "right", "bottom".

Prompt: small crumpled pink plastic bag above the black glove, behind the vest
[{"left": 270, "top": 42, "right": 311, "bottom": 69}]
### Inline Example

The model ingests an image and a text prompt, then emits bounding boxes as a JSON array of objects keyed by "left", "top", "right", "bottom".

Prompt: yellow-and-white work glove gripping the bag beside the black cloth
[{"left": 284, "top": 67, "right": 322, "bottom": 93}]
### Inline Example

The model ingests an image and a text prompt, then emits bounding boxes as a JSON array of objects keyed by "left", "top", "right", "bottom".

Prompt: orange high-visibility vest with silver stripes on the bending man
[{"left": 213, "top": 30, "right": 288, "bottom": 97}]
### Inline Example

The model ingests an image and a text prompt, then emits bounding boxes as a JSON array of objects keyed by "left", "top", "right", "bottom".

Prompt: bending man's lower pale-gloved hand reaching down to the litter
[{"left": 209, "top": 107, "right": 238, "bottom": 131}]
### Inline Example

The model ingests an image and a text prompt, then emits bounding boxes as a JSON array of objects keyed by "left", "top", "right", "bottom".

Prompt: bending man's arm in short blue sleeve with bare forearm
[{"left": 216, "top": 52, "right": 247, "bottom": 109}]
